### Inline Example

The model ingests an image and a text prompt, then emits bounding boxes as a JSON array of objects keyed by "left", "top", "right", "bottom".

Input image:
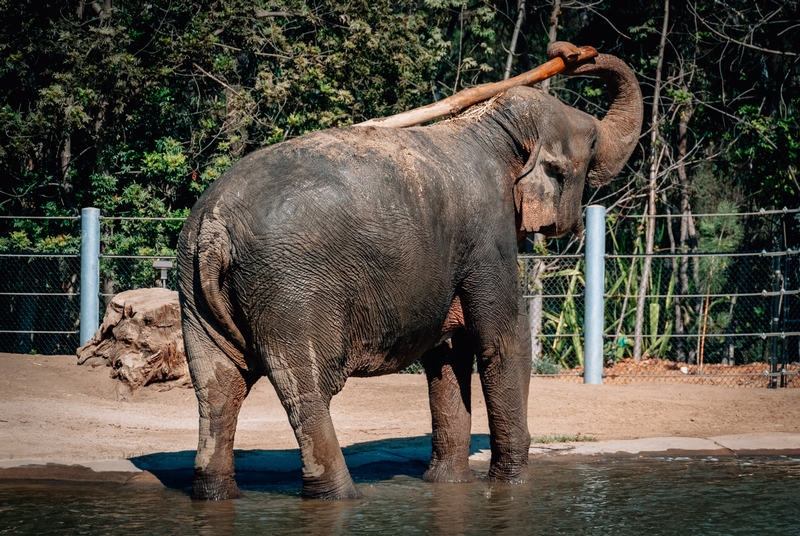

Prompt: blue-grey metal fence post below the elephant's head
[{"left": 583, "top": 205, "right": 606, "bottom": 385}]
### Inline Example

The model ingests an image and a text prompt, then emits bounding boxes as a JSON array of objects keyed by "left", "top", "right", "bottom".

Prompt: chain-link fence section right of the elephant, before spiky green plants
[{"left": 520, "top": 211, "right": 800, "bottom": 387}]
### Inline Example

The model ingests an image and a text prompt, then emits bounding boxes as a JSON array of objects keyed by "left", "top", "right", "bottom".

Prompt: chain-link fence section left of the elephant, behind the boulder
[{"left": 0, "top": 217, "right": 178, "bottom": 354}]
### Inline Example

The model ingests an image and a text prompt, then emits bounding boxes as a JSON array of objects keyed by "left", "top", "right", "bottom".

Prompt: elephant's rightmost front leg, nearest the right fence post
[{"left": 478, "top": 308, "right": 531, "bottom": 483}]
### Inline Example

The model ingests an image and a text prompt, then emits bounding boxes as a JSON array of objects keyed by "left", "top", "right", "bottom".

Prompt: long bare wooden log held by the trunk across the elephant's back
[{"left": 356, "top": 46, "right": 597, "bottom": 128}]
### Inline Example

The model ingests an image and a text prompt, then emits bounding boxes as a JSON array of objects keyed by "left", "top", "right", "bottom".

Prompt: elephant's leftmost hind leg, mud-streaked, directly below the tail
[{"left": 183, "top": 317, "right": 259, "bottom": 500}]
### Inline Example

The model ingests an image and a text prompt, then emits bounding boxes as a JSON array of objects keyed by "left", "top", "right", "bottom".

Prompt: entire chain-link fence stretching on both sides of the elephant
[{"left": 0, "top": 209, "right": 800, "bottom": 387}]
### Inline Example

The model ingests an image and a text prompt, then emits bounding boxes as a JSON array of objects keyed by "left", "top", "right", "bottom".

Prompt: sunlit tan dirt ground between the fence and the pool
[{"left": 0, "top": 354, "right": 800, "bottom": 461}]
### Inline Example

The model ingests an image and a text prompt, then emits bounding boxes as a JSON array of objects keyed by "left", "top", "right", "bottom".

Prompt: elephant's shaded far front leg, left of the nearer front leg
[{"left": 422, "top": 334, "right": 473, "bottom": 482}]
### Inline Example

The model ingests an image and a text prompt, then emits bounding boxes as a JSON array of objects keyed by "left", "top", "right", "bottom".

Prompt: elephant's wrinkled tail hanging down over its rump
[{"left": 196, "top": 218, "right": 248, "bottom": 370}]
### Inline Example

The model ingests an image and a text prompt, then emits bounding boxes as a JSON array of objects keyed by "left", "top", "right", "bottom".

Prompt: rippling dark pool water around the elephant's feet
[{"left": 0, "top": 457, "right": 800, "bottom": 535}]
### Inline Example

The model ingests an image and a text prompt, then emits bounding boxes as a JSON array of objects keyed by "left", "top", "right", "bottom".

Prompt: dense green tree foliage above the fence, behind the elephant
[{"left": 0, "top": 0, "right": 798, "bottom": 230}]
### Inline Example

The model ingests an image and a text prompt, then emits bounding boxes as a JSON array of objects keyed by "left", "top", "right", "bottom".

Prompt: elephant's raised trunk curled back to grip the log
[{"left": 547, "top": 43, "right": 644, "bottom": 187}]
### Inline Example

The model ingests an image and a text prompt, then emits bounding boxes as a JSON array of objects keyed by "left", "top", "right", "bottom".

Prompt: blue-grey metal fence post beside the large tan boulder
[{"left": 80, "top": 208, "right": 100, "bottom": 346}]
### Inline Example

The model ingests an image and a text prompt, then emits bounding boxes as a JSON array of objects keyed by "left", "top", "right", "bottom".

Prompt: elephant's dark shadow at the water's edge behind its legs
[{"left": 130, "top": 434, "right": 489, "bottom": 493}]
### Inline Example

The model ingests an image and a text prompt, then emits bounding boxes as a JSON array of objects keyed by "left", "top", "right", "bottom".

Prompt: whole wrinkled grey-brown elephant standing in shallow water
[{"left": 178, "top": 44, "right": 642, "bottom": 499}]
